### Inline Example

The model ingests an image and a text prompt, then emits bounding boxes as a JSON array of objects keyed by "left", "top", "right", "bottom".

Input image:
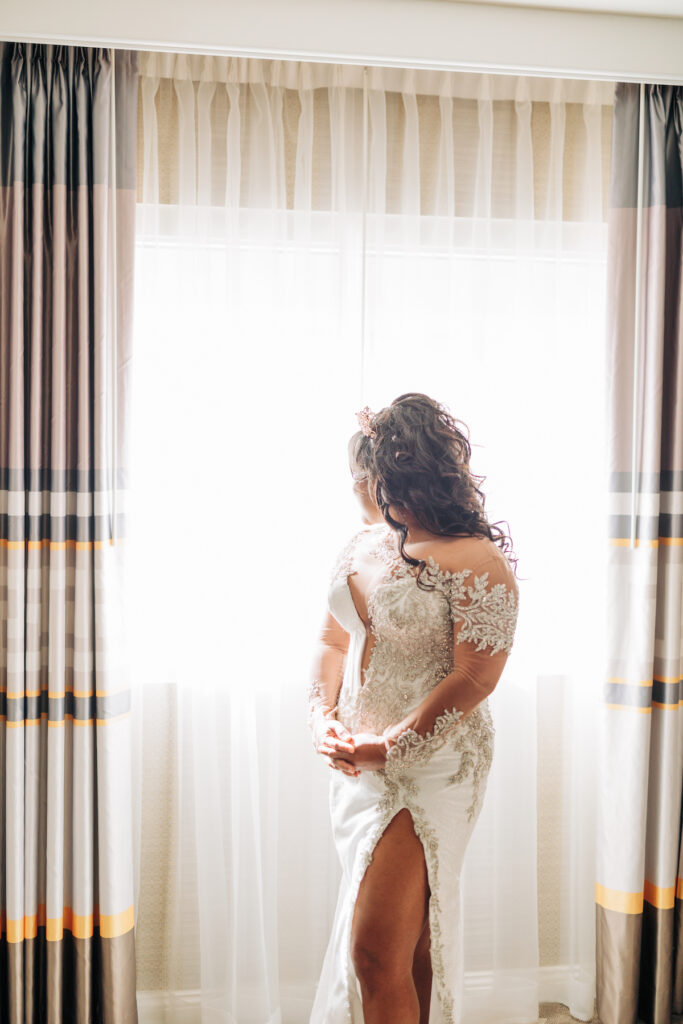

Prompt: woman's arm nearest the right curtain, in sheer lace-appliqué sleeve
[{"left": 385, "top": 557, "right": 519, "bottom": 769}]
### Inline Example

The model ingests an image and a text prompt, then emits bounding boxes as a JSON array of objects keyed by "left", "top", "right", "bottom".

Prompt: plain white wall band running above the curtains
[{"left": 0, "top": 0, "right": 683, "bottom": 83}]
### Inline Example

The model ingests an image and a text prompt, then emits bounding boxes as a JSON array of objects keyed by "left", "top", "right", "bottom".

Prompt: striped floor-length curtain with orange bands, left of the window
[{"left": 0, "top": 43, "right": 137, "bottom": 1024}]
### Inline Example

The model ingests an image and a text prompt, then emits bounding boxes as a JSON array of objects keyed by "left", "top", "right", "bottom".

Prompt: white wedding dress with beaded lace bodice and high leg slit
[{"left": 309, "top": 523, "right": 518, "bottom": 1024}]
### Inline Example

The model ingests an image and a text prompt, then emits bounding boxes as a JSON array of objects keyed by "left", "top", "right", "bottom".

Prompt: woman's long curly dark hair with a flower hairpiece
[{"left": 348, "top": 391, "right": 518, "bottom": 590}]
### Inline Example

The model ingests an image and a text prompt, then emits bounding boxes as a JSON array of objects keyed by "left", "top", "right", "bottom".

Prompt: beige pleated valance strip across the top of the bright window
[{"left": 138, "top": 52, "right": 613, "bottom": 223}]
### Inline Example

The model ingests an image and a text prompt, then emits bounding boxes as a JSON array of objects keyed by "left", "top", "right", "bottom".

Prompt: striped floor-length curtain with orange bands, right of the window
[{"left": 596, "top": 84, "right": 683, "bottom": 1024}]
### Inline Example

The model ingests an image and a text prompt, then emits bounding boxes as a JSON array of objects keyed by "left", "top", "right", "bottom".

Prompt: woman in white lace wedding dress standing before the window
[{"left": 309, "top": 392, "right": 519, "bottom": 1024}]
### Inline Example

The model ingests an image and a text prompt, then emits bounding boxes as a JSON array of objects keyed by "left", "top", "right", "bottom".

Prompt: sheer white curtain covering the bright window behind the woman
[{"left": 127, "top": 53, "right": 612, "bottom": 1024}]
